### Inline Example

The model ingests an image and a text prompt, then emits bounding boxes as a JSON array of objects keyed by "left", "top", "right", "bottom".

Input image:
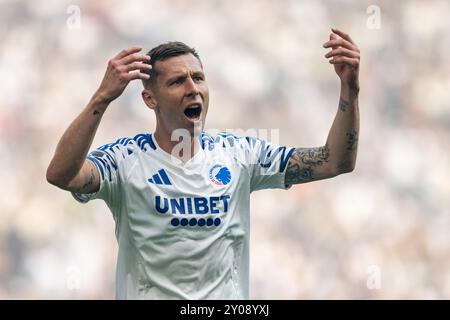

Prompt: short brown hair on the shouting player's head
[{"left": 141, "top": 41, "right": 203, "bottom": 88}]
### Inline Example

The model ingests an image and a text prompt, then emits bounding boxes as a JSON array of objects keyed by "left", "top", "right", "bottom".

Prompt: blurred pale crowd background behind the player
[{"left": 0, "top": 0, "right": 450, "bottom": 299}]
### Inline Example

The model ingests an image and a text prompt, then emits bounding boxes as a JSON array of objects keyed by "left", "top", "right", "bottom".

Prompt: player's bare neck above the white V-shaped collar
[{"left": 153, "top": 126, "right": 201, "bottom": 162}]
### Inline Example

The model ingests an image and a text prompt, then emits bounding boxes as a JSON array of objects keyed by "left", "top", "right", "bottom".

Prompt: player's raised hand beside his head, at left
[{"left": 96, "top": 47, "right": 152, "bottom": 103}]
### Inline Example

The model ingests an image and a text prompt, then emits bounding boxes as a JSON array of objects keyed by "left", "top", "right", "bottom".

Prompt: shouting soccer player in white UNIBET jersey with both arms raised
[{"left": 47, "top": 28, "right": 360, "bottom": 299}]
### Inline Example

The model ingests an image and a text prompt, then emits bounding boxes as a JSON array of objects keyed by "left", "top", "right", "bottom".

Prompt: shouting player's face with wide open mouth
[{"left": 148, "top": 54, "right": 209, "bottom": 134}]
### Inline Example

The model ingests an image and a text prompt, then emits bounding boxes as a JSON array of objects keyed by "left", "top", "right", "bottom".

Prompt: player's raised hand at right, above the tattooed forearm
[{"left": 323, "top": 28, "right": 360, "bottom": 89}]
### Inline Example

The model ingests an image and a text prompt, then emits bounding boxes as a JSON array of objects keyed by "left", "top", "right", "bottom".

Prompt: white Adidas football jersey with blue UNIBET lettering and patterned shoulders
[{"left": 73, "top": 133, "right": 294, "bottom": 299}]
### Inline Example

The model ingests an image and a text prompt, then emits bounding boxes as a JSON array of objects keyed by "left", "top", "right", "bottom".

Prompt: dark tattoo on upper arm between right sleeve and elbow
[{"left": 285, "top": 145, "right": 330, "bottom": 185}]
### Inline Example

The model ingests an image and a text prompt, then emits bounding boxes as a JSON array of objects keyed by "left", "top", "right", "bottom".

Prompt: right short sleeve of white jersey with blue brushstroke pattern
[{"left": 245, "top": 137, "right": 295, "bottom": 192}]
